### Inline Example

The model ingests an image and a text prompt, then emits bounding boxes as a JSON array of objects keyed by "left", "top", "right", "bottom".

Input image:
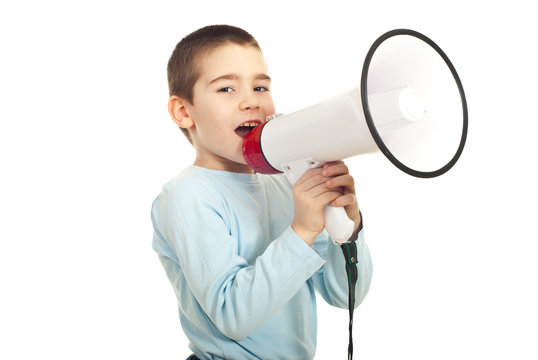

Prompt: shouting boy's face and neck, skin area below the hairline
[{"left": 185, "top": 43, "right": 275, "bottom": 172}]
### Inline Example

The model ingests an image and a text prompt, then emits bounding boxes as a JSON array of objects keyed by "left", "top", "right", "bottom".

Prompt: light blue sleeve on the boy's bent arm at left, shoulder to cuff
[{"left": 152, "top": 177, "right": 324, "bottom": 340}]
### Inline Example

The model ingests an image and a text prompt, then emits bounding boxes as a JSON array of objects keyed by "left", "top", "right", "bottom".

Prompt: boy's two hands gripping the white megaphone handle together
[{"left": 291, "top": 161, "right": 361, "bottom": 246}]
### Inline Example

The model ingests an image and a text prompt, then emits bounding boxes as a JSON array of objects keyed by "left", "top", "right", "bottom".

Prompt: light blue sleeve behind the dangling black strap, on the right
[{"left": 312, "top": 229, "right": 372, "bottom": 308}]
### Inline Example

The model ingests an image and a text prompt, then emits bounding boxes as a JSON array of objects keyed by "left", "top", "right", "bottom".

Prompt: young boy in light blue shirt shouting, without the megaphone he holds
[{"left": 152, "top": 25, "right": 372, "bottom": 360}]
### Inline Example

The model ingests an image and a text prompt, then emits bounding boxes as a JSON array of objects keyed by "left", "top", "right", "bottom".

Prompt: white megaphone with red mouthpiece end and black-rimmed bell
[{"left": 243, "top": 29, "right": 468, "bottom": 244}]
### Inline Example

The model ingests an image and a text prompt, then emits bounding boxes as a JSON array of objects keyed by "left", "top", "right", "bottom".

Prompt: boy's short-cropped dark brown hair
[{"left": 167, "top": 25, "right": 261, "bottom": 142}]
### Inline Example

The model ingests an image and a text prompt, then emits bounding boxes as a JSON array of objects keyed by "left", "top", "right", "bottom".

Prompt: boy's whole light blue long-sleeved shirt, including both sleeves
[{"left": 152, "top": 166, "right": 372, "bottom": 360}]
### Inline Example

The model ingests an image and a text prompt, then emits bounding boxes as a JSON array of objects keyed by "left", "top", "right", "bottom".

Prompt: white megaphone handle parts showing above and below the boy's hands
[{"left": 282, "top": 158, "right": 355, "bottom": 244}]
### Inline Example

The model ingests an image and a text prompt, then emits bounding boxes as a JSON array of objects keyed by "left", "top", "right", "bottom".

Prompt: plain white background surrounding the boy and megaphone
[{"left": 0, "top": 0, "right": 538, "bottom": 360}]
